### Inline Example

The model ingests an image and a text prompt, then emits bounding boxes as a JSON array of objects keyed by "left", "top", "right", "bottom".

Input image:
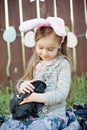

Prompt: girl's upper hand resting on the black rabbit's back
[{"left": 20, "top": 81, "right": 34, "bottom": 93}]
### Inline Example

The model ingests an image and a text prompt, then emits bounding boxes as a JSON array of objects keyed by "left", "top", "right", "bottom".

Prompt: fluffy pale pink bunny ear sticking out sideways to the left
[{"left": 19, "top": 18, "right": 46, "bottom": 32}]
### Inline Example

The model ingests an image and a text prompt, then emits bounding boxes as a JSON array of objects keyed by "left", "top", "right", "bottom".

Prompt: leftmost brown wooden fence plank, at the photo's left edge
[{"left": 0, "top": 0, "right": 9, "bottom": 85}]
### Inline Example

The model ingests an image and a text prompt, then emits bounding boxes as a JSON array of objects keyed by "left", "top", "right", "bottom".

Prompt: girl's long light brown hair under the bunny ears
[{"left": 21, "top": 27, "right": 67, "bottom": 80}]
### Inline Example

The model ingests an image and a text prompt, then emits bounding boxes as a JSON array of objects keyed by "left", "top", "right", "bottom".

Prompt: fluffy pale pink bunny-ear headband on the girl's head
[{"left": 19, "top": 17, "right": 66, "bottom": 39}]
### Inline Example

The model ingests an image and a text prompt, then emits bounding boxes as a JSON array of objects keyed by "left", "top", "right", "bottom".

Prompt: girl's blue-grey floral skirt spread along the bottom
[{"left": 0, "top": 111, "right": 80, "bottom": 130}]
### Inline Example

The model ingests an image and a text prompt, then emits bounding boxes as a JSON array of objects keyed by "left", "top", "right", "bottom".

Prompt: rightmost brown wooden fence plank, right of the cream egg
[{"left": 73, "top": 0, "right": 87, "bottom": 75}]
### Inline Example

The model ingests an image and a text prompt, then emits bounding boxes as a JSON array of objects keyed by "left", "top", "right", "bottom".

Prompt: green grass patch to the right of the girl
[{"left": 67, "top": 72, "right": 87, "bottom": 107}]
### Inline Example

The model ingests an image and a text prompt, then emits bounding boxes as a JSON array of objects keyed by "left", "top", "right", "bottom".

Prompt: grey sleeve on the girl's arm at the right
[{"left": 45, "top": 60, "right": 71, "bottom": 105}]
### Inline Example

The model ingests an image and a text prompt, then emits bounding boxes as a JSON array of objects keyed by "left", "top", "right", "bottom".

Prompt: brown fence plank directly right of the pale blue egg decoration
[{"left": 8, "top": 0, "right": 23, "bottom": 83}]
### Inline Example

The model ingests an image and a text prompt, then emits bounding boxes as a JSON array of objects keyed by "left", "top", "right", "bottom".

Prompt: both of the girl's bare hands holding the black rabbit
[{"left": 18, "top": 80, "right": 46, "bottom": 104}]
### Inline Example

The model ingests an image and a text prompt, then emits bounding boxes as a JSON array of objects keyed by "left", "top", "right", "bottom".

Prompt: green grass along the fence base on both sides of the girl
[{"left": 0, "top": 73, "right": 87, "bottom": 115}]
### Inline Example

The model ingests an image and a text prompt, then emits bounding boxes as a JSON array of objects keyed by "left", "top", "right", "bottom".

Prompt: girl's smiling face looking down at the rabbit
[{"left": 36, "top": 34, "right": 59, "bottom": 61}]
